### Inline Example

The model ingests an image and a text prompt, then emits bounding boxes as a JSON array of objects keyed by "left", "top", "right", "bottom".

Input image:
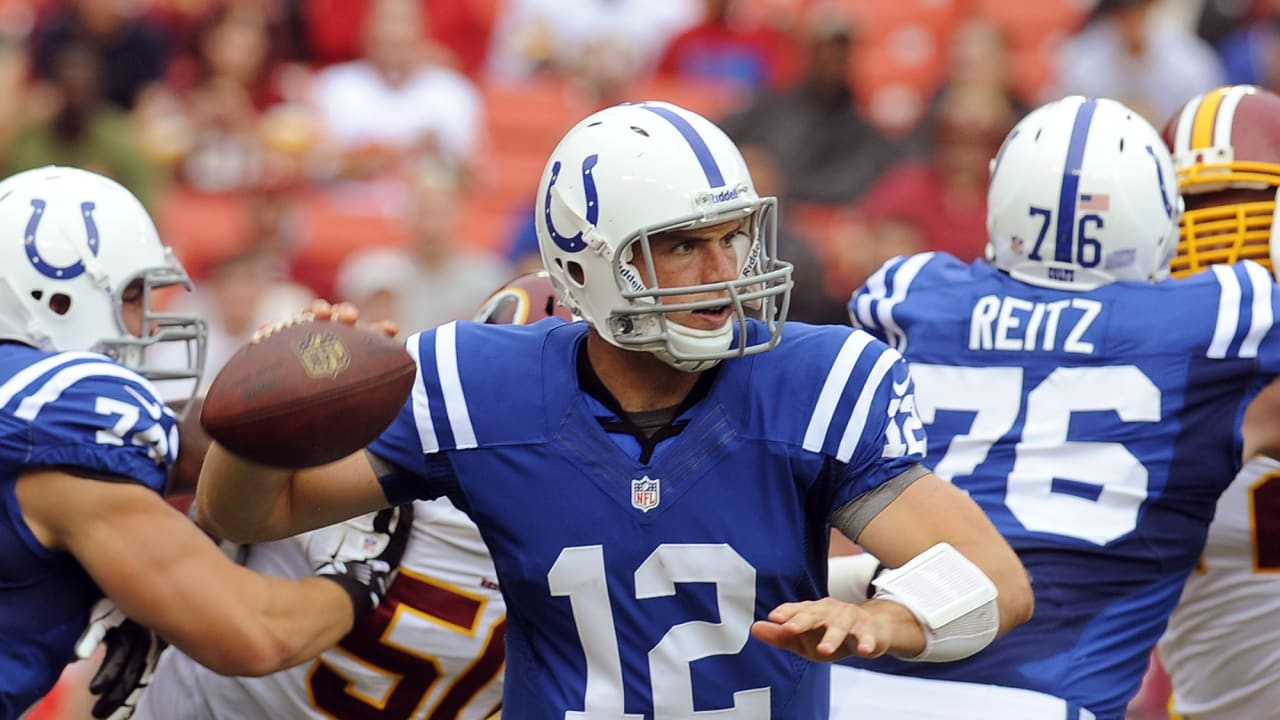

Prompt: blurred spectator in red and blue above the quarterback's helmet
[{"left": 658, "top": 0, "right": 796, "bottom": 92}]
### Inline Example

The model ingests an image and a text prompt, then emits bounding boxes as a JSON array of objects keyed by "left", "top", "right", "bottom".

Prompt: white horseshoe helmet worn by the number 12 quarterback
[{"left": 535, "top": 102, "right": 791, "bottom": 372}]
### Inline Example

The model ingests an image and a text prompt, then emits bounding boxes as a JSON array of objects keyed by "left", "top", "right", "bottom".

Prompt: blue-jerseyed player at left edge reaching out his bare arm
[{"left": 0, "top": 167, "right": 404, "bottom": 720}]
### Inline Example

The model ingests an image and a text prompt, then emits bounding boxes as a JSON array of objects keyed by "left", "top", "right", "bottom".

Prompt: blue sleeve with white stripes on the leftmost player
[{"left": 10, "top": 357, "right": 178, "bottom": 492}]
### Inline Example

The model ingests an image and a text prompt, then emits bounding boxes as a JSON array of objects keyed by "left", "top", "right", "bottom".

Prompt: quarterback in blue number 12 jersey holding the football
[{"left": 198, "top": 102, "right": 1032, "bottom": 720}]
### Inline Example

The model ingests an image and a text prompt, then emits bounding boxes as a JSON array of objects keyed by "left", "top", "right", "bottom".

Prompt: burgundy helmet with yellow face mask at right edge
[{"left": 1164, "top": 85, "right": 1280, "bottom": 277}]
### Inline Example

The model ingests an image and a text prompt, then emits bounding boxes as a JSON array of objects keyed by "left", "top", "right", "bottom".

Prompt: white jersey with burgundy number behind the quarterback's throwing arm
[{"left": 134, "top": 500, "right": 507, "bottom": 720}]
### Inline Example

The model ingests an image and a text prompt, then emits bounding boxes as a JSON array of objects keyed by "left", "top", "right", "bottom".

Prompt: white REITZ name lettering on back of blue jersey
[{"left": 969, "top": 295, "right": 1102, "bottom": 355}]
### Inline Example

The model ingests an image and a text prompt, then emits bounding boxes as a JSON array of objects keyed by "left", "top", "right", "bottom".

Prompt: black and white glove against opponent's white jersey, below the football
[{"left": 306, "top": 502, "right": 413, "bottom": 621}]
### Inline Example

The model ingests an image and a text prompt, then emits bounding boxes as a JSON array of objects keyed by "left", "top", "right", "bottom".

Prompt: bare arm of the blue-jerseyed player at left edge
[{"left": 18, "top": 470, "right": 353, "bottom": 675}]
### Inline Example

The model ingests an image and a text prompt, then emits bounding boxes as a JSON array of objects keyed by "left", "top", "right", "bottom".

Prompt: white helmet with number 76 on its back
[{"left": 987, "top": 96, "right": 1183, "bottom": 290}]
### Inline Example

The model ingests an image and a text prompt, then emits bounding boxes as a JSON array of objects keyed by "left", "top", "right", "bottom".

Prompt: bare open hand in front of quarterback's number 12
[{"left": 751, "top": 597, "right": 890, "bottom": 662}]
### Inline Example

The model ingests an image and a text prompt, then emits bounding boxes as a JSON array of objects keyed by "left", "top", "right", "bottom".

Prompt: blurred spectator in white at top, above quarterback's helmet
[{"left": 488, "top": 0, "right": 699, "bottom": 79}]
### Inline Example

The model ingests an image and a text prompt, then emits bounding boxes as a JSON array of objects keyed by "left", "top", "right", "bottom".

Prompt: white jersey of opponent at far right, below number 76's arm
[{"left": 1160, "top": 456, "right": 1280, "bottom": 720}]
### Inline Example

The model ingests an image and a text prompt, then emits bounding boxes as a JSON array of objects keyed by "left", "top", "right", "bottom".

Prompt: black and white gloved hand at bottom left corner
[{"left": 76, "top": 598, "right": 165, "bottom": 720}]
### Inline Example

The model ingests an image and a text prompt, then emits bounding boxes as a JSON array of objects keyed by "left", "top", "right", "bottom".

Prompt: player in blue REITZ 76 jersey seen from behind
[{"left": 832, "top": 97, "right": 1280, "bottom": 720}]
